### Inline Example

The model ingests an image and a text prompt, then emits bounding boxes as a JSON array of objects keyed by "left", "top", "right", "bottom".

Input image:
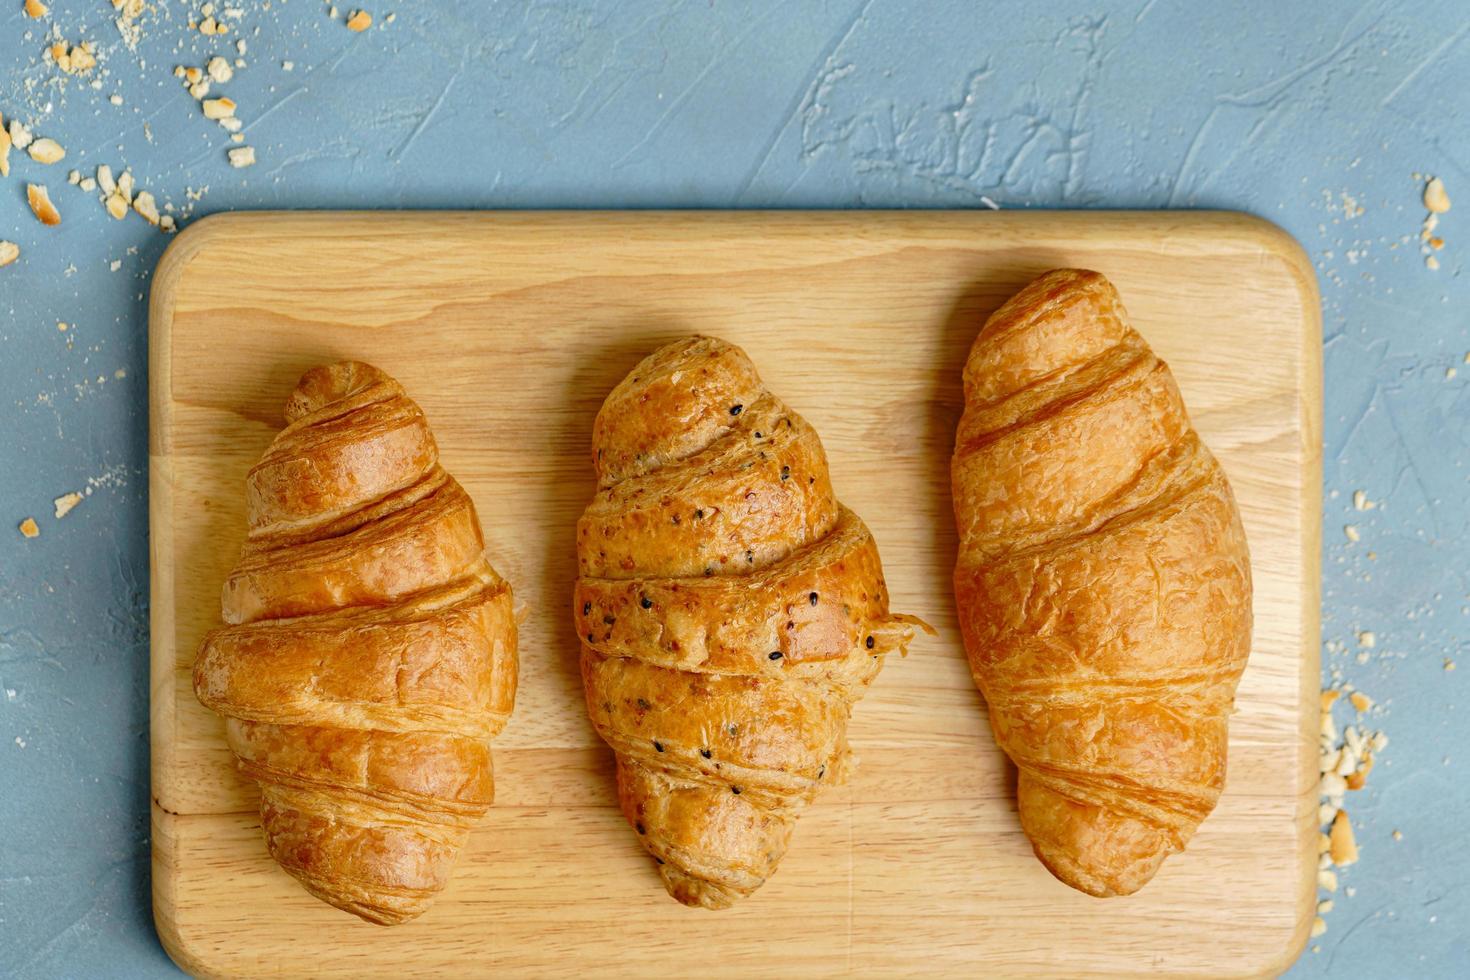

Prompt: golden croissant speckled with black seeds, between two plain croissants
[{"left": 573, "top": 336, "right": 911, "bottom": 908}]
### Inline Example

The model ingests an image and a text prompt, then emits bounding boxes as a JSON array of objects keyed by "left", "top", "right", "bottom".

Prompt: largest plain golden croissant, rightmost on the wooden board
[{"left": 953, "top": 269, "right": 1251, "bottom": 896}]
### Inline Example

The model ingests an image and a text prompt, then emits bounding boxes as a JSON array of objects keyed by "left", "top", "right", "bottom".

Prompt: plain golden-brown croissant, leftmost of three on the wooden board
[{"left": 194, "top": 361, "right": 516, "bottom": 926}]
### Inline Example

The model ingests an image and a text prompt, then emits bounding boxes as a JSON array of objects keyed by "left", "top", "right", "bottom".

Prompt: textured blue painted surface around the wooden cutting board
[{"left": 0, "top": 0, "right": 1470, "bottom": 977}]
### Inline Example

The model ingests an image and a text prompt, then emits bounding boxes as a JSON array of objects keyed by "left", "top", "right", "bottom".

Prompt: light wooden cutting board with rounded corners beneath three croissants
[{"left": 148, "top": 212, "right": 1322, "bottom": 977}]
